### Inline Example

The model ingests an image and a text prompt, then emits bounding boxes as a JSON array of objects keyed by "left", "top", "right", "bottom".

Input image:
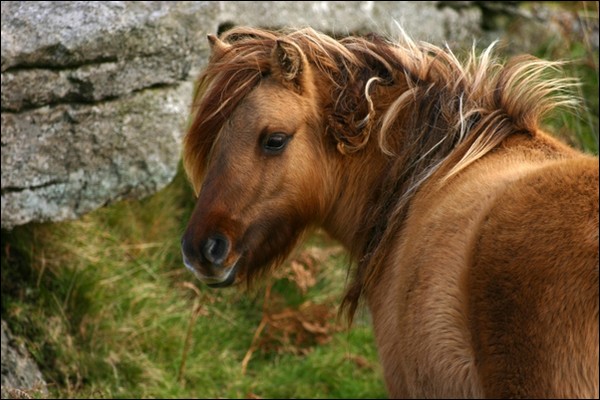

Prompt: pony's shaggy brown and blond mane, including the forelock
[{"left": 183, "top": 28, "right": 576, "bottom": 318}]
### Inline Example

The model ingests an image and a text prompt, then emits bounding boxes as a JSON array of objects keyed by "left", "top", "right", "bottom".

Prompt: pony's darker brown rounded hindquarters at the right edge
[{"left": 468, "top": 152, "right": 599, "bottom": 398}]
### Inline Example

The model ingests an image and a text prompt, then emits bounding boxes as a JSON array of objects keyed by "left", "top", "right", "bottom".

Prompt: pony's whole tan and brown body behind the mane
[{"left": 369, "top": 132, "right": 598, "bottom": 398}]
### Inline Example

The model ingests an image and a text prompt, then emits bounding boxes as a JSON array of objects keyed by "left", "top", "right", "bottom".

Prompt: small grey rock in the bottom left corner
[{"left": 2, "top": 320, "right": 48, "bottom": 399}]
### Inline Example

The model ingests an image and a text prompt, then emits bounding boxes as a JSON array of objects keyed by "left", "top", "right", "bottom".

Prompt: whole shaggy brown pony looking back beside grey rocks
[{"left": 182, "top": 28, "right": 599, "bottom": 398}]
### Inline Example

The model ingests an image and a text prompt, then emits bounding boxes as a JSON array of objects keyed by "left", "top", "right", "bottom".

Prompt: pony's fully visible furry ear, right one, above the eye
[{"left": 271, "top": 40, "right": 309, "bottom": 93}]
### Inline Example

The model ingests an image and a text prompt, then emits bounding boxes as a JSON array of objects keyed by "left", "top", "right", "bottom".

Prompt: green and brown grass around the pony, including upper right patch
[{"left": 1, "top": 3, "right": 598, "bottom": 398}]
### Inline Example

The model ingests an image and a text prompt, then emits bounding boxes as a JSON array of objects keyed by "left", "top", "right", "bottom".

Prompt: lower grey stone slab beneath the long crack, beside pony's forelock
[{"left": 2, "top": 83, "right": 192, "bottom": 226}]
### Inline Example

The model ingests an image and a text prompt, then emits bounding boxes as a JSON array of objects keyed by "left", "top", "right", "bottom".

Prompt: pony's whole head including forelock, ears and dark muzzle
[{"left": 182, "top": 28, "right": 336, "bottom": 287}]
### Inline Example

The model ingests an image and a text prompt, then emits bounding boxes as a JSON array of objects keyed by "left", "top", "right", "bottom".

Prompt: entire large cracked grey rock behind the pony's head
[{"left": 1, "top": 1, "right": 480, "bottom": 229}]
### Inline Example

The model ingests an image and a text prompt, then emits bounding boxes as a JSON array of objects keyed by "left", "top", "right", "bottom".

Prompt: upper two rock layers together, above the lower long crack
[{"left": 2, "top": 2, "right": 216, "bottom": 111}]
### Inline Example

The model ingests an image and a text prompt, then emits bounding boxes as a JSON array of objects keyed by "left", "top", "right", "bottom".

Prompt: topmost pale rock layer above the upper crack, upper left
[{"left": 1, "top": 1, "right": 217, "bottom": 71}]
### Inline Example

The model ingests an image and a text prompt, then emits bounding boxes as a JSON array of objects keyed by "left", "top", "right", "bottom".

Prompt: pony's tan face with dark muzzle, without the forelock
[{"left": 182, "top": 38, "right": 327, "bottom": 287}]
